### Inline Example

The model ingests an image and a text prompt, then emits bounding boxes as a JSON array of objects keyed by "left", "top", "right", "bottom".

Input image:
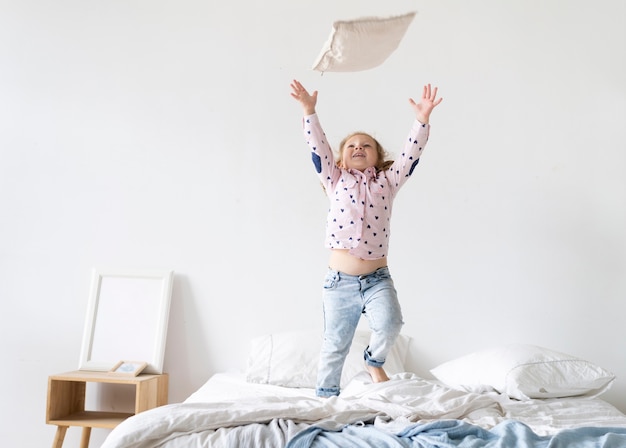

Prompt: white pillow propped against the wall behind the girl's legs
[{"left": 246, "top": 330, "right": 410, "bottom": 388}]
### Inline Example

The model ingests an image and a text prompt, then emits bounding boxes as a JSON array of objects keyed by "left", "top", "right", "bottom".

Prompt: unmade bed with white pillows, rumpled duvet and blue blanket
[{"left": 103, "top": 331, "right": 626, "bottom": 448}]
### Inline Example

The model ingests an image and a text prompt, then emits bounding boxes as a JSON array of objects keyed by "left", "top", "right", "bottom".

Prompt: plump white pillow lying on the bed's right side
[{"left": 431, "top": 344, "right": 615, "bottom": 400}]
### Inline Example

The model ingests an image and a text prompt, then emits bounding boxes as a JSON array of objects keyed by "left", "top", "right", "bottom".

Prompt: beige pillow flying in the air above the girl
[{"left": 313, "top": 12, "right": 416, "bottom": 72}]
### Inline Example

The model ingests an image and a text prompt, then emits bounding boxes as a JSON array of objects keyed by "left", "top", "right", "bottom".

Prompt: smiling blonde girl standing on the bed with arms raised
[{"left": 291, "top": 80, "right": 442, "bottom": 397}]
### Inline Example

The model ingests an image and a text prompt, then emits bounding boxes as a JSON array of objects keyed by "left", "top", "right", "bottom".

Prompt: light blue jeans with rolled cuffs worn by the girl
[{"left": 316, "top": 267, "right": 404, "bottom": 397}]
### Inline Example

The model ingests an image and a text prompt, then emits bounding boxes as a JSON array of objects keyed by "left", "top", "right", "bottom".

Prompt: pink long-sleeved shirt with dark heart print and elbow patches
[{"left": 304, "top": 114, "right": 430, "bottom": 260}]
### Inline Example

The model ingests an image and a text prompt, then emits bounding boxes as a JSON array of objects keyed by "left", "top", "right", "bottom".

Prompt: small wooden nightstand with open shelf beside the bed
[{"left": 46, "top": 370, "right": 168, "bottom": 448}]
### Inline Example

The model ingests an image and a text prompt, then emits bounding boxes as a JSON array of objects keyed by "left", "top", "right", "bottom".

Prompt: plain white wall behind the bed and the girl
[{"left": 0, "top": 0, "right": 626, "bottom": 446}]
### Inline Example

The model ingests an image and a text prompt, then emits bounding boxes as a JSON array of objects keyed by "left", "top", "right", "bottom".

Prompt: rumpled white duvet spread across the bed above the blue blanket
[{"left": 103, "top": 373, "right": 626, "bottom": 448}]
